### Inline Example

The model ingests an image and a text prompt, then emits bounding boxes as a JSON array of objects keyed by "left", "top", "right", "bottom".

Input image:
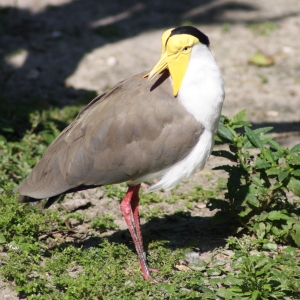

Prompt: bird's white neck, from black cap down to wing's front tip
[{"left": 178, "top": 44, "right": 224, "bottom": 133}]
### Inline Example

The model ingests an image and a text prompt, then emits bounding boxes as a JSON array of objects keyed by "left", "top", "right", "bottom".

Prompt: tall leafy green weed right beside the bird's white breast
[{"left": 209, "top": 110, "right": 300, "bottom": 246}]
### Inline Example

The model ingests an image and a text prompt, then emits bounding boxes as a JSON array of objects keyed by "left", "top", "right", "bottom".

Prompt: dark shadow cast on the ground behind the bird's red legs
[{"left": 47, "top": 212, "right": 227, "bottom": 256}]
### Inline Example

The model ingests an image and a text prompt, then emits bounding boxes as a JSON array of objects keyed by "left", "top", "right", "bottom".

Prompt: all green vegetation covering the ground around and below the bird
[{"left": 0, "top": 102, "right": 300, "bottom": 300}]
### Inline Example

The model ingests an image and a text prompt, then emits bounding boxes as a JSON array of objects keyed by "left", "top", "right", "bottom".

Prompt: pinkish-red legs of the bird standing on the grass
[{"left": 120, "top": 184, "right": 155, "bottom": 282}]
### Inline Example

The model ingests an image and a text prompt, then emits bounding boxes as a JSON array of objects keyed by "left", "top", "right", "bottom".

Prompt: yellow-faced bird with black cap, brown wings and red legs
[{"left": 17, "top": 26, "right": 225, "bottom": 282}]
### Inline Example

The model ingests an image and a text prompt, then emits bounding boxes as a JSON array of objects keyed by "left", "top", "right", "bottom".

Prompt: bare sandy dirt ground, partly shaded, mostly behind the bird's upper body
[{"left": 0, "top": 0, "right": 300, "bottom": 299}]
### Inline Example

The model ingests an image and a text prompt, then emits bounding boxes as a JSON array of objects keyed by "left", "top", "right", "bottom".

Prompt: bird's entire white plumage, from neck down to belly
[{"left": 148, "top": 44, "right": 224, "bottom": 192}]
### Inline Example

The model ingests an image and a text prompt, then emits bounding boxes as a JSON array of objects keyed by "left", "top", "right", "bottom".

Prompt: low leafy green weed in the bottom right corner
[{"left": 218, "top": 237, "right": 300, "bottom": 299}]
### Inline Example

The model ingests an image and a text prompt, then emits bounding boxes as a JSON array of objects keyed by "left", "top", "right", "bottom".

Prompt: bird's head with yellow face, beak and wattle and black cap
[{"left": 144, "top": 26, "right": 209, "bottom": 96}]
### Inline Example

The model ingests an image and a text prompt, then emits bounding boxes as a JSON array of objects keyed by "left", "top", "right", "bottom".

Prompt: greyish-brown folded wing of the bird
[{"left": 18, "top": 74, "right": 202, "bottom": 199}]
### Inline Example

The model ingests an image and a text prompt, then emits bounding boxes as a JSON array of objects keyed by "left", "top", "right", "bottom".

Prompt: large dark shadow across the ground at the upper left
[{"left": 0, "top": 0, "right": 298, "bottom": 136}]
